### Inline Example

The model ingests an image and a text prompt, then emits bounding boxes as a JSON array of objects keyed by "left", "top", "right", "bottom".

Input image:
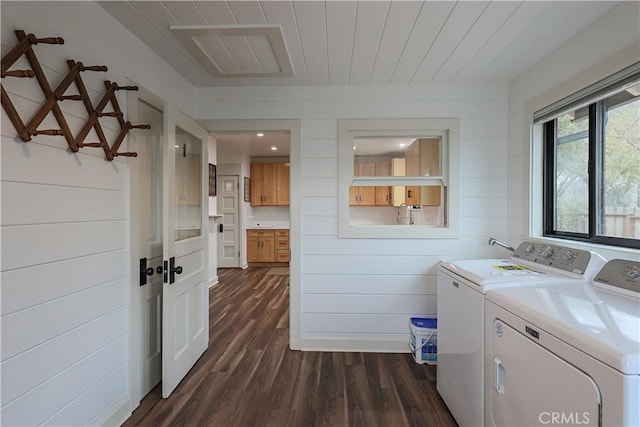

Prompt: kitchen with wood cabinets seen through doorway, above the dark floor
[{"left": 213, "top": 130, "right": 291, "bottom": 268}]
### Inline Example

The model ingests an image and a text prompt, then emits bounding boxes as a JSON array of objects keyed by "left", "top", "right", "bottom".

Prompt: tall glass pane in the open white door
[{"left": 175, "top": 127, "right": 202, "bottom": 241}]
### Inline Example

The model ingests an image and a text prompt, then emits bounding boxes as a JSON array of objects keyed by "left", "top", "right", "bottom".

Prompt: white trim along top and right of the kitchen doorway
[{"left": 196, "top": 119, "right": 302, "bottom": 350}]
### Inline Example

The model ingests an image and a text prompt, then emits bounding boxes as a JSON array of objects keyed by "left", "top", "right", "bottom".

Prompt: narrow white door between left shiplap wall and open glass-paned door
[{"left": 130, "top": 94, "right": 164, "bottom": 406}]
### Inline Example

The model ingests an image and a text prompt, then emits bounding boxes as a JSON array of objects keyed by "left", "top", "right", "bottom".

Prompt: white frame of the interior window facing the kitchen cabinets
[{"left": 338, "top": 118, "right": 460, "bottom": 239}]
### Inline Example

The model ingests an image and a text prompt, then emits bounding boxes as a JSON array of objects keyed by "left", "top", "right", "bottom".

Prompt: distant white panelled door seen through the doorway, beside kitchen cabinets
[{"left": 218, "top": 175, "right": 240, "bottom": 268}]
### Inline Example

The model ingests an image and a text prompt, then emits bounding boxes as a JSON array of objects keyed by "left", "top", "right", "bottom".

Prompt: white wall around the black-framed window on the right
[{"left": 508, "top": 2, "right": 640, "bottom": 259}]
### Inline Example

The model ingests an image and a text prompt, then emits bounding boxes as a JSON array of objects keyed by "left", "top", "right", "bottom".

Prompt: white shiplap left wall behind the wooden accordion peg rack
[{"left": 0, "top": 1, "right": 193, "bottom": 425}]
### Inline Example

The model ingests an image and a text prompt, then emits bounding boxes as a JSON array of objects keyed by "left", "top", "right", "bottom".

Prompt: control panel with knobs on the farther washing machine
[{"left": 513, "top": 241, "right": 591, "bottom": 274}]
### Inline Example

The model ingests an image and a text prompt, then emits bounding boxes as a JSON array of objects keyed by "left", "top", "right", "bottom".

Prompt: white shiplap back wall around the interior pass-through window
[{"left": 195, "top": 85, "right": 507, "bottom": 351}]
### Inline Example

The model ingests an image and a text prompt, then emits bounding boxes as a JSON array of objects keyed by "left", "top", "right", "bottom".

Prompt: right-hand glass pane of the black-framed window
[{"left": 599, "top": 93, "right": 640, "bottom": 239}]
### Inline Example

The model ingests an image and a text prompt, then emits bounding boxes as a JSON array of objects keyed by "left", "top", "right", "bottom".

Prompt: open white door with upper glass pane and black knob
[{"left": 162, "top": 108, "right": 209, "bottom": 398}]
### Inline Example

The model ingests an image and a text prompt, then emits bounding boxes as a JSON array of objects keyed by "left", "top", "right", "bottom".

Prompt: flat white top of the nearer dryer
[{"left": 486, "top": 284, "right": 640, "bottom": 375}]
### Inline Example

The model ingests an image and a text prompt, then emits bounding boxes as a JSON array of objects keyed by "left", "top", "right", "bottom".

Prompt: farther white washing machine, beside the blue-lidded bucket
[{"left": 437, "top": 241, "right": 605, "bottom": 426}]
